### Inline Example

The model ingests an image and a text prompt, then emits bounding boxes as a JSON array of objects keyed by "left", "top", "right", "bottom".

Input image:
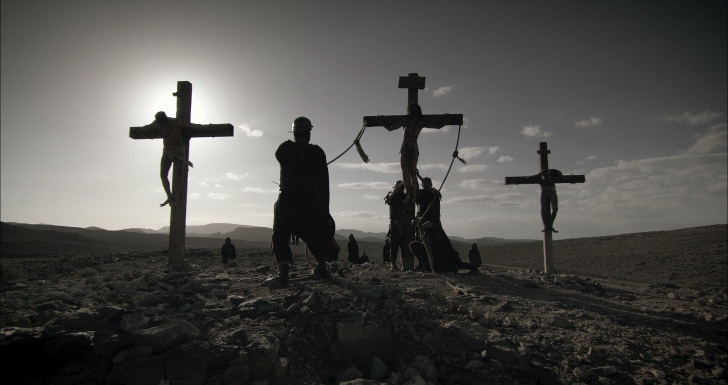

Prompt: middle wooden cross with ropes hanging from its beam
[{"left": 364, "top": 73, "right": 463, "bottom": 270}]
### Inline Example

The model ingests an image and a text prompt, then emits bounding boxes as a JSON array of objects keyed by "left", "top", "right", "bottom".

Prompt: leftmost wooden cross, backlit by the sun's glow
[{"left": 129, "top": 81, "right": 234, "bottom": 268}]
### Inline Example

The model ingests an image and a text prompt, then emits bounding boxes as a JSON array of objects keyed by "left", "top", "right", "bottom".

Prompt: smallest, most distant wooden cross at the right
[{"left": 506, "top": 142, "right": 585, "bottom": 274}]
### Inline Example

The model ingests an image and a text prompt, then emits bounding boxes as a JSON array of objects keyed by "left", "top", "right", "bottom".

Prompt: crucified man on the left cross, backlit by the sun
[{"left": 139, "top": 111, "right": 194, "bottom": 207}]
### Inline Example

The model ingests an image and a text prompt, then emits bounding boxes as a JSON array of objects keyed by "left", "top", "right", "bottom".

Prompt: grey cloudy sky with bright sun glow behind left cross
[{"left": 0, "top": 0, "right": 728, "bottom": 239}]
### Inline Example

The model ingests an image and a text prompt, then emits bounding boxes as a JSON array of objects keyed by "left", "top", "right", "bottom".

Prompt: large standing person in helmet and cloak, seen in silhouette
[{"left": 272, "top": 117, "right": 340, "bottom": 285}]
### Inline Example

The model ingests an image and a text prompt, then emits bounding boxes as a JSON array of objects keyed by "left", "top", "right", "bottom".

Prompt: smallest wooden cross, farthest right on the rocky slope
[{"left": 506, "top": 142, "right": 586, "bottom": 274}]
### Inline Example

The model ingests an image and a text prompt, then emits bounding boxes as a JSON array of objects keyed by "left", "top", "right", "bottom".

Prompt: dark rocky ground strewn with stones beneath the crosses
[{"left": 0, "top": 225, "right": 728, "bottom": 385}]
